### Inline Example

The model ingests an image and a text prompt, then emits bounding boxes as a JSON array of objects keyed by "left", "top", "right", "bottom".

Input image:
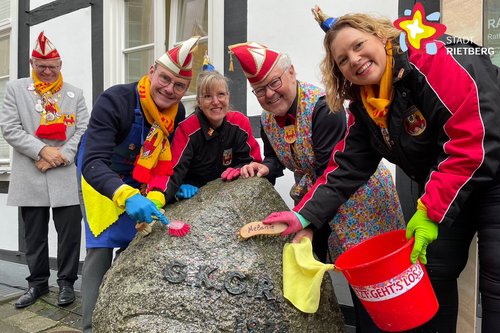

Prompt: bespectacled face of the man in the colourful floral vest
[{"left": 252, "top": 65, "right": 297, "bottom": 116}]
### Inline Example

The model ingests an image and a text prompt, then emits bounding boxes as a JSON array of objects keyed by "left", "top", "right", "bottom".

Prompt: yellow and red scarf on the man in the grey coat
[{"left": 31, "top": 70, "right": 66, "bottom": 141}]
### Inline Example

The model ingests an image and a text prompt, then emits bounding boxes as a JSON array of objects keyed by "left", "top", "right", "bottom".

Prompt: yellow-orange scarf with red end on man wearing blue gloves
[{"left": 132, "top": 75, "right": 179, "bottom": 183}]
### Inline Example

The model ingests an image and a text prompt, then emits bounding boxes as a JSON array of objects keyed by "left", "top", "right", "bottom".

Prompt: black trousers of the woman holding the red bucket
[{"left": 416, "top": 174, "right": 500, "bottom": 333}]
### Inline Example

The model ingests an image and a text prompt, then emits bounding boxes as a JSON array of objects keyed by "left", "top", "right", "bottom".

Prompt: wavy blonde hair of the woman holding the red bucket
[{"left": 320, "top": 13, "right": 401, "bottom": 112}]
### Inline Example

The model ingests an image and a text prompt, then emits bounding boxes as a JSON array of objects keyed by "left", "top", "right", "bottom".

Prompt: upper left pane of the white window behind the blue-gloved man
[{"left": 125, "top": 0, "right": 154, "bottom": 48}]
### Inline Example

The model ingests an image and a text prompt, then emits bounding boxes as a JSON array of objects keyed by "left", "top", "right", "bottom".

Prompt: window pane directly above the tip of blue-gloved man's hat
[{"left": 177, "top": 0, "right": 208, "bottom": 42}]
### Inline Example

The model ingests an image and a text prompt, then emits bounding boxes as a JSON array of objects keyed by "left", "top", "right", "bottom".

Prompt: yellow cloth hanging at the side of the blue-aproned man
[{"left": 81, "top": 176, "right": 126, "bottom": 237}]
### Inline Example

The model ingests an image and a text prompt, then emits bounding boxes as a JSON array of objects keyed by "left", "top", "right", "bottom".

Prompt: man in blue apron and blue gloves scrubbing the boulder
[{"left": 78, "top": 37, "right": 199, "bottom": 332}]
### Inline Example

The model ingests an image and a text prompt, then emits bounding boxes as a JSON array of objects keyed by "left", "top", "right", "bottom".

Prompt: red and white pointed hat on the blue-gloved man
[{"left": 156, "top": 36, "right": 200, "bottom": 79}]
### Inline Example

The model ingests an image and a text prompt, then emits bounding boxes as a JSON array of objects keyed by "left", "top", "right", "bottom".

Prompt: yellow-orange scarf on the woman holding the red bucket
[{"left": 361, "top": 41, "right": 392, "bottom": 129}]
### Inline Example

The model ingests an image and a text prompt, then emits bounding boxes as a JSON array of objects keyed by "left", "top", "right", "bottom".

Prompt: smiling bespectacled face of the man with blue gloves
[{"left": 149, "top": 65, "right": 190, "bottom": 111}]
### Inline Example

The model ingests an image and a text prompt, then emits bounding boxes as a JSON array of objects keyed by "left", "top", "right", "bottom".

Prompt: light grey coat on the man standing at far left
[{"left": 0, "top": 78, "right": 89, "bottom": 207}]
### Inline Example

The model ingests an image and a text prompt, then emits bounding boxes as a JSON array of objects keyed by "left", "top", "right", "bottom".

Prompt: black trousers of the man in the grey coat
[{"left": 21, "top": 205, "right": 82, "bottom": 287}]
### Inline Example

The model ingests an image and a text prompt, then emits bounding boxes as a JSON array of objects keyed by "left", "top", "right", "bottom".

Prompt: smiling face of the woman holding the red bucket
[{"left": 330, "top": 27, "right": 387, "bottom": 86}]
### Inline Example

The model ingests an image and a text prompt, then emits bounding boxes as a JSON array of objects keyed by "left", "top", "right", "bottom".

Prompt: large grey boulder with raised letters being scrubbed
[{"left": 93, "top": 178, "right": 344, "bottom": 333}]
